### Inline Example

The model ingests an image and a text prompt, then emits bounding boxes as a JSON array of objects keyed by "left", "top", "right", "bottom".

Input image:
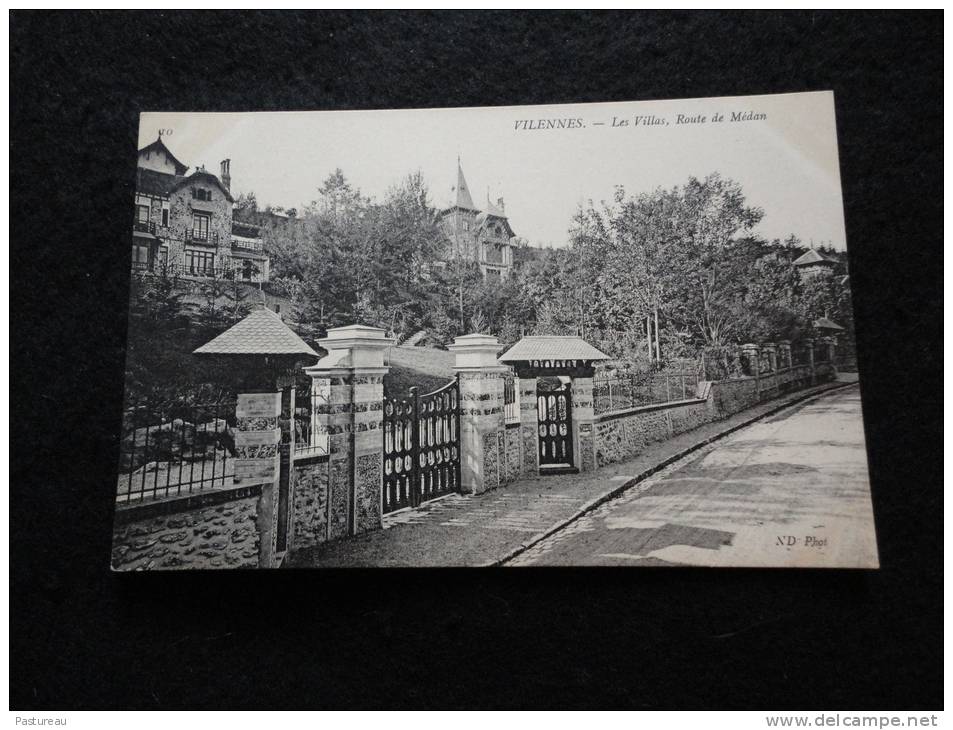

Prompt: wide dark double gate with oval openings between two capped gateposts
[{"left": 383, "top": 380, "right": 460, "bottom": 513}]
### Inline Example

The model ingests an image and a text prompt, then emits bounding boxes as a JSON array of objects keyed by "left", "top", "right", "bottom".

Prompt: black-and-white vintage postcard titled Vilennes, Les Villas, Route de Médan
[{"left": 112, "top": 92, "right": 878, "bottom": 571}]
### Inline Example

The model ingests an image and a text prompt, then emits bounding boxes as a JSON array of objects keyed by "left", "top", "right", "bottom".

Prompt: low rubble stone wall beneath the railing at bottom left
[{"left": 112, "top": 484, "right": 275, "bottom": 571}]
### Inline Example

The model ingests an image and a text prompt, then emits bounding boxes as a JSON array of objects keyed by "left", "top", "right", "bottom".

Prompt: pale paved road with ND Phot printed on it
[{"left": 508, "top": 386, "right": 877, "bottom": 568}]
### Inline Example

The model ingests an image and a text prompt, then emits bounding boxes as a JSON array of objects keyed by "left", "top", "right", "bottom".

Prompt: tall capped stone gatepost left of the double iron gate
[{"left": 305, "top": 325, "right": 393, "bottom": 540}]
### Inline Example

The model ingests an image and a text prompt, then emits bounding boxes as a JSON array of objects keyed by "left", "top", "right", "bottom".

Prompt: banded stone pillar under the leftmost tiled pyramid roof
[{"left": 233, "top": 391, "right": 281, "bottom": 568}]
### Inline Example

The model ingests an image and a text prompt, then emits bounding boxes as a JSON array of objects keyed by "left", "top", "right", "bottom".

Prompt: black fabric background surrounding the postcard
[{"left": 10, "top": 12, "right": 943, "bottom": 709}]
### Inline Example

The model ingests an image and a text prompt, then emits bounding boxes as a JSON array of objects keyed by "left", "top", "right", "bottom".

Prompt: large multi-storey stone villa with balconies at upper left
[{"left": 132, "top": 136, "right": 269, "bottom": 282}]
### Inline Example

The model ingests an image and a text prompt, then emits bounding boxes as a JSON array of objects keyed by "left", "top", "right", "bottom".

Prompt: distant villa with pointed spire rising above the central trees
[{"left": 440, "top": 163, "right": 516, "bottom": 279}]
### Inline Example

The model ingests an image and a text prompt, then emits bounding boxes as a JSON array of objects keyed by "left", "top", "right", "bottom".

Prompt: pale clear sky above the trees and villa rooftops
[{"left": 139, "top": 92, "right": 845, "bottom": 249}]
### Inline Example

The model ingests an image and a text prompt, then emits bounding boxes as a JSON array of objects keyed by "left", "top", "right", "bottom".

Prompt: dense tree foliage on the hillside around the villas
[{"left": 130, "top": 170, "right": 852, "bottom": 396}]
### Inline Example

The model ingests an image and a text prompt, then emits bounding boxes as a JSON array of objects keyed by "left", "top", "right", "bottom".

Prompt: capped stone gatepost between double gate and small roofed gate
[{"left": 447, "top": 334, "right": 509, "bottom": 494}]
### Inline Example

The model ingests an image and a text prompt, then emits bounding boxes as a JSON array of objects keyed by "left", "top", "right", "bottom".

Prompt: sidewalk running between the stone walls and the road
[{"left": 285, "top": 374, "right": 857, "bottom": 568}]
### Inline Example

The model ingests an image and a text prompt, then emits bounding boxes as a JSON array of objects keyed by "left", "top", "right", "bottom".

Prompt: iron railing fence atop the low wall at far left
[{"left": 116, "top": 400, "right": 235, "bottom": 503}]
